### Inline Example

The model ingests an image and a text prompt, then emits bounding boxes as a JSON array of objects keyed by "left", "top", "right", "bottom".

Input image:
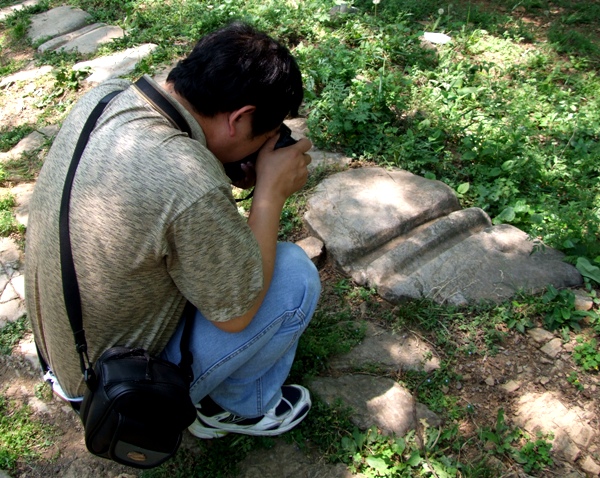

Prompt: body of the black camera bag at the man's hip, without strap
[{"left": 80, "top": 347, "right": 196, "bottom": 468}]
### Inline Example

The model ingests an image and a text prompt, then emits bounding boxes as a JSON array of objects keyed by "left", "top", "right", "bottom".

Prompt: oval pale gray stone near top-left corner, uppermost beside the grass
[{"left": 27, "top": 6, "right": 92, "bottom": 43}]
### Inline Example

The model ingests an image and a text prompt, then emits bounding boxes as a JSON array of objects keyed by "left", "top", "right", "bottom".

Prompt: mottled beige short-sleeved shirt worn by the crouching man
[{"left": 25, "top": 75, "right": 263, "bottom": 397}]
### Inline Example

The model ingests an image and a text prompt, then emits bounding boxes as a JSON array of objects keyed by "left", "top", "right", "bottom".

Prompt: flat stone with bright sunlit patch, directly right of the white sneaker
[{"left": 310, "top": 375, "right": 440, "bottom": 436}]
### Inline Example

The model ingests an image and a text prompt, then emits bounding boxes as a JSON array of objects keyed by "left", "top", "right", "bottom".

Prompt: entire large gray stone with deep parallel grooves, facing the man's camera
[{"left": 304, "top": 168, "right": 582, "bottom": 305}]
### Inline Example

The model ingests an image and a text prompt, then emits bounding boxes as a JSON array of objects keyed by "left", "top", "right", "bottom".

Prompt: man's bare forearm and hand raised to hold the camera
[{"left": 213, "top": 137, "right": 312, "bottom": 332}]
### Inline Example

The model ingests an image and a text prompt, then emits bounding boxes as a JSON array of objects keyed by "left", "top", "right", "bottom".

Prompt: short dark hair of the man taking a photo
[{"left": 167, "top": 22, "right": 303, "bottom": 136}]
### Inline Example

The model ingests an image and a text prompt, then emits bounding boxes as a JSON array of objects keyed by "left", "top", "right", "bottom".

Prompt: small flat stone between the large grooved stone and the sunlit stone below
[{"left": 329, "top": 322, "right": 440, "bottom": 372}]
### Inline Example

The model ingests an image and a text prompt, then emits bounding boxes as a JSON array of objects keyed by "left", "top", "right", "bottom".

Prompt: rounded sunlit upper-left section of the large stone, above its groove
[{"left": 304, "top": 168, "right": 460, "bottom": 267}]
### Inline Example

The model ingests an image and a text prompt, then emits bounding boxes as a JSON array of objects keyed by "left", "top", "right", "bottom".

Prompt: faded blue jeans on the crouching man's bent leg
[{"left": 162, "top": 243, "right": 321, "bottom": 418}]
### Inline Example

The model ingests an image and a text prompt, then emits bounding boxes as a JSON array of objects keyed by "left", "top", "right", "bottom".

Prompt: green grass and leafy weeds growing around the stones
[{"left": 0, "top": 0, "right": 600, "bottom": 478}]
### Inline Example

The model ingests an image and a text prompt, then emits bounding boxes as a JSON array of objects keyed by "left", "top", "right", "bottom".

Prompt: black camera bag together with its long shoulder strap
[{"left": 59, "top": 79, "right": 196, "bottom": 468}]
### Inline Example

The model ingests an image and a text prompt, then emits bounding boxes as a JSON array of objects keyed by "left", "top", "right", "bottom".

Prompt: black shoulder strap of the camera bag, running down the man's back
[{"left": 59, "top": 84, "right": 195, "bottom": 388}]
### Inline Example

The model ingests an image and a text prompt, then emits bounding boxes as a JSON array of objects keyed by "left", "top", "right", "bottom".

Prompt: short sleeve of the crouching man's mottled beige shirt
[{"left": 167, "top": 185, "right": 263, "bottom": 322}]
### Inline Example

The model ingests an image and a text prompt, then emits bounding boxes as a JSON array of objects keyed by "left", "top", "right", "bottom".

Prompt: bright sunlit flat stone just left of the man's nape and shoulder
[{"left": 73, "top": 43, "right": 157, "bottom": 85}]
